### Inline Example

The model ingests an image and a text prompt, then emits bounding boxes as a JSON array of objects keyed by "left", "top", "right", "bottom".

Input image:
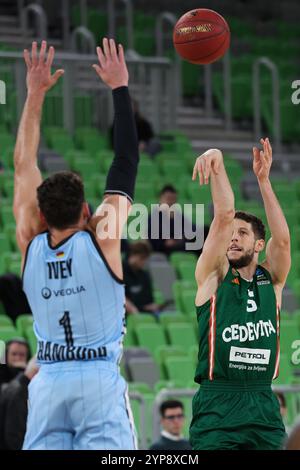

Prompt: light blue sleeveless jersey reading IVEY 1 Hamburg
[{"left": 23, "top": 231, "right": 125, "bottom": 364}]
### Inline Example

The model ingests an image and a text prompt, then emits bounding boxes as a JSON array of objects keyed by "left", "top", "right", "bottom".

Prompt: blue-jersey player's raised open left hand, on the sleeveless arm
[{"left": 24, "top": 41, "right": 64, "bottom": 94}]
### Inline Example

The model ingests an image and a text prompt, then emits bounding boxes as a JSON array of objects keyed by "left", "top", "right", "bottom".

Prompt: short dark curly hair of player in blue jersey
[{"left": 37, "top": 171, "right": 84, "bottom": 230}]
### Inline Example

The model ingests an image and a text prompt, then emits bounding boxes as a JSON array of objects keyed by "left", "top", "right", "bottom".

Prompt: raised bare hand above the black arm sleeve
[{"left": 93, "top": 38, "right": 128, "bottom": 90}]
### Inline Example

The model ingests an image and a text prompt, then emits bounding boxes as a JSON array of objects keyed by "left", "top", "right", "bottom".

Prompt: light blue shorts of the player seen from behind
[{"left": 23, "top": 361, "right": 137, "bottom": 450}]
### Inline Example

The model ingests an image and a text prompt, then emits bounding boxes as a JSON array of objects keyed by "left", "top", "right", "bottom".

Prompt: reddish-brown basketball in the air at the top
[{"left": 173, "top": 8, "right": 230, "bottom": 64}]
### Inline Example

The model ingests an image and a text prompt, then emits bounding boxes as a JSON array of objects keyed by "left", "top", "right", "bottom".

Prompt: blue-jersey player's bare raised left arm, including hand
[{"left": 13, "top": 41, "right": 63, "bottom": 255}]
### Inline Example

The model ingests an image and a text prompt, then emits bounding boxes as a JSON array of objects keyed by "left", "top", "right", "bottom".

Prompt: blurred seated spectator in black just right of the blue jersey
[{"left": 123, "top": 241, "right": 159, "bottom": 313}]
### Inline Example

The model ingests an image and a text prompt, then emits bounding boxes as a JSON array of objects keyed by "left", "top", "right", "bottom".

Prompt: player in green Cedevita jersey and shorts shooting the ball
[{"left": 190, "top": 139, "right": 291, "bottom": 450}]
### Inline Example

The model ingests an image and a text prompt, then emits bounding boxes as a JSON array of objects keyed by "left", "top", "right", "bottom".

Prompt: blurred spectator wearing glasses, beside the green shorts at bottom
[{"left": 150, "top": 400, "right": 192, "bottom": 450}]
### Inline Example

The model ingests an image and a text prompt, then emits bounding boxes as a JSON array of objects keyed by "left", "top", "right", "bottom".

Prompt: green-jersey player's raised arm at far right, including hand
[{"left": 253, "top": 138, "right": 291, "bottom": 287}]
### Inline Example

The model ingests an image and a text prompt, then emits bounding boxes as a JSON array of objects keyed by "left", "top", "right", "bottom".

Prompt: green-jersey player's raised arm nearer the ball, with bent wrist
[{"left": 193, "top": 149, "right": 235, "bottom": 305}]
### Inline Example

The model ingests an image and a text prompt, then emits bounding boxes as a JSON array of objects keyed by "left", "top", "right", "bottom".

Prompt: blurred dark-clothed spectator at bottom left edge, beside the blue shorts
[{"left": 0, "top": 357, "right": 39, "bottom": 450}]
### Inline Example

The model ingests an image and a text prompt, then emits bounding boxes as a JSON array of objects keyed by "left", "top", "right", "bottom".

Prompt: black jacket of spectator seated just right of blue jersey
[{"left": 123, "top": 261, "right": 153, "bottom": 311}]
